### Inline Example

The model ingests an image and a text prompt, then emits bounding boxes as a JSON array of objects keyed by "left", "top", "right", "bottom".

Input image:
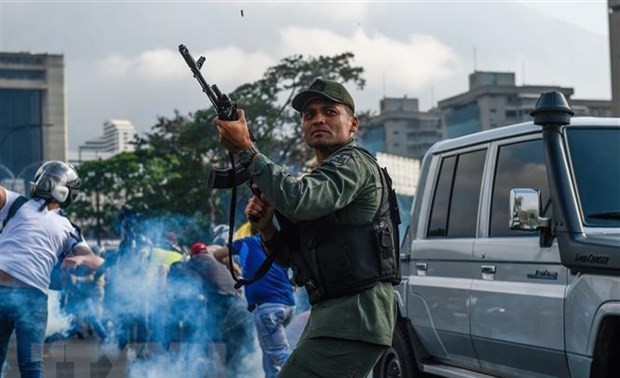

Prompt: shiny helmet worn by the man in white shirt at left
[{"left": 30, "top": 160, "right": 80, "bottom": 208}]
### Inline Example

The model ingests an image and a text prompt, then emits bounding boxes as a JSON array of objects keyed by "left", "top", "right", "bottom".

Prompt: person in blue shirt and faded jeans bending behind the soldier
[{"left": 213, "top": 224, "right": 295, "bottom": 378}]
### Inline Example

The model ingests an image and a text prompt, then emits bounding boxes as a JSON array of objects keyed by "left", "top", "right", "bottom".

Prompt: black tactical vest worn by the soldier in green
[{"left": 291, "top": 147, "right": 401, "bottom": 304}]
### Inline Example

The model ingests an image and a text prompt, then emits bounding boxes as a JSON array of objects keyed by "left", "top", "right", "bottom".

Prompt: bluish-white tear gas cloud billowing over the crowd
[{"left": 100, "top": 214, "right": 262, "bottom": 378}]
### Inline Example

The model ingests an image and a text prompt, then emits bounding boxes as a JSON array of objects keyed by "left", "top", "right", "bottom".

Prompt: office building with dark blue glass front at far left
[{"left": 0, "top": 52, "right": 67, "bottom": 188}]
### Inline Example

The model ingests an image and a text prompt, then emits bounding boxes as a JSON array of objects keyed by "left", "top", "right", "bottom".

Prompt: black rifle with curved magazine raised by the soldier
[{"left": 179, "top": 45, "right": 256, "bottom": 189}]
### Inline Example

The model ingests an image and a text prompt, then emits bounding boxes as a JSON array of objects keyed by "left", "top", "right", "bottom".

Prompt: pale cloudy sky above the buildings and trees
[{"left": 0, "top": 0, "right": 611, "bottom": 151}]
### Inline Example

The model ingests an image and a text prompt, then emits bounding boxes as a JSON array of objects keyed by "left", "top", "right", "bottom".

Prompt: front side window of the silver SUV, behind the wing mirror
[{"left": 489, "top": 139, "right": 551, "bottom": 237}]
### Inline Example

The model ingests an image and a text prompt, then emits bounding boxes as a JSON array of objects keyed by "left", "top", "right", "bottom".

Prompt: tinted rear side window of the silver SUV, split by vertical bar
[{"left": 427, "top": 149, "right": 487, "bottom": 238}]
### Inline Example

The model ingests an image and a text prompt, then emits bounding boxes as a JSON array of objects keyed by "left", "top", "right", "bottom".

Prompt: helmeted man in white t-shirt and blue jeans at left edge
[{"left": 0, "top": 161, "right": 103, "bottom": 377}]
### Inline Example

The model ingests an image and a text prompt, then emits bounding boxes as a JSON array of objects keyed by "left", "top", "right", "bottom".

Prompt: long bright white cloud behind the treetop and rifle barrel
[{"left": 89, "top": 25, "right": 462, "bottom": 113}]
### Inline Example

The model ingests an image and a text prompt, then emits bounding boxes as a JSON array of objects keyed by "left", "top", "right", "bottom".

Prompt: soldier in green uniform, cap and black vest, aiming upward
[{"left": 214, "top": 79, "right": 399, "bottom": 378}]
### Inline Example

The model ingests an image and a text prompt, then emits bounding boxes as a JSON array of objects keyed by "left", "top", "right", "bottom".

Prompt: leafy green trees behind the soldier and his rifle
[{"left": 70, "top": 52, "right": 365, "bottom": 244}]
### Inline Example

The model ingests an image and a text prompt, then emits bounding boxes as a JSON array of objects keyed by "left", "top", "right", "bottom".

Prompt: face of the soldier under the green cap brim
[{"left": 301, "top": 98, "right": 358, "bottom": 149}]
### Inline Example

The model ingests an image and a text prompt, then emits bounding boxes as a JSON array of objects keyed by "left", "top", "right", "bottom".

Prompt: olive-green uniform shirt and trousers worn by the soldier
[{"left": 248, "top": 140, "right": 396, "bottom": 378}]
